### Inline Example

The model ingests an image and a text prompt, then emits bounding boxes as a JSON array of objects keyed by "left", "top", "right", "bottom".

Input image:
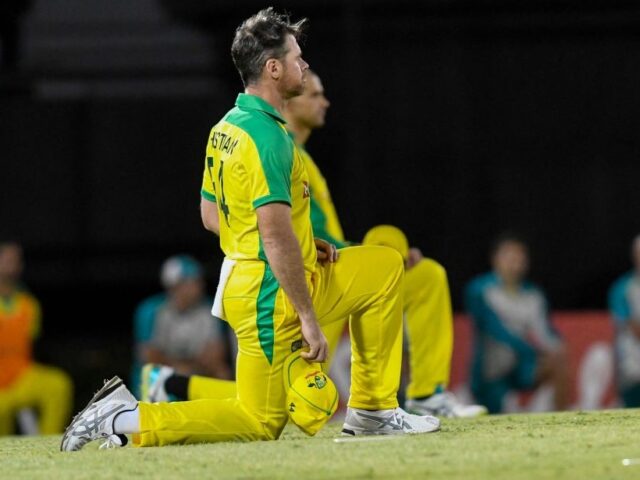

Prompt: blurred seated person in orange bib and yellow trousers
[{"left": 0, "top": 242, "right": 72, "bottom": 435}]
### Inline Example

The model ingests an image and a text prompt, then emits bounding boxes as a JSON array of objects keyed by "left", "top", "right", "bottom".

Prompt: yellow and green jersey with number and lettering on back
[{"left": 201, "top": 94, "right": 316, "bottom": 272}]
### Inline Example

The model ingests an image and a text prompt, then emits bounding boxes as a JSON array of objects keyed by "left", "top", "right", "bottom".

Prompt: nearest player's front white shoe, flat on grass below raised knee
[{"left": 342, "top": 407, "right": 440, "bottom": 436}]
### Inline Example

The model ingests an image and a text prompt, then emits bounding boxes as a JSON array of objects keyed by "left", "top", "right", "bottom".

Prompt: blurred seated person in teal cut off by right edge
[{"left": 609, "top": 235, "right": 640, "bottom": 407}]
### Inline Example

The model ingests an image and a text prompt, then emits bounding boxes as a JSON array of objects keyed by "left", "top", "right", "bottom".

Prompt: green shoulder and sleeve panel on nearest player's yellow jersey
[{"left": 224, "top": 107, "right": 293, "bottom": 208}]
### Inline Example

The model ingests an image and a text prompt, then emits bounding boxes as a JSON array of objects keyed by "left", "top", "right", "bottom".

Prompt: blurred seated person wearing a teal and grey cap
[{"left": 133, "top": 255, "right": 231, "bottom": 396}]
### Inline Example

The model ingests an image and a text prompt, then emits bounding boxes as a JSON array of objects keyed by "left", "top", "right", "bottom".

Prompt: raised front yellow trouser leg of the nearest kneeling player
[{"left": 312, "top": 246, "right": 404, "bottom": 410}]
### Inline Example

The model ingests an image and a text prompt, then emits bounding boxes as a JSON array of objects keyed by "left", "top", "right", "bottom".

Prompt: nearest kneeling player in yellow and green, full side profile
[{"left": 60, "top": 8, "right": 440, "bottom": 451}]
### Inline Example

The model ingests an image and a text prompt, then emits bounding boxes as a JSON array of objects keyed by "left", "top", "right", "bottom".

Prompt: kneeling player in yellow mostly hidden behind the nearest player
[{"left": 142, "top": 71, "right": 487, "bottom": 417}]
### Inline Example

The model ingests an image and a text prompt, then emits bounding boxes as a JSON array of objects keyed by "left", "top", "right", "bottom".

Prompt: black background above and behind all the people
[{"left": 0, "top": 0, "right": 640, "bottom": 400}]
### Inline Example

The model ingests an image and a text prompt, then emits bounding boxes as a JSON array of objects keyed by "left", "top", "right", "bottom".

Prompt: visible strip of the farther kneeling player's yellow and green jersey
[{"left": 298, "top": 146, "right": 347, "bottom": 248}]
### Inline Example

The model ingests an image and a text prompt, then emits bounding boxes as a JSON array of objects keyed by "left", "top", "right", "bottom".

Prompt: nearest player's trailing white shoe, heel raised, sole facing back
[{"left": 60, "top": 377, "right": 138, "bottom": 452}]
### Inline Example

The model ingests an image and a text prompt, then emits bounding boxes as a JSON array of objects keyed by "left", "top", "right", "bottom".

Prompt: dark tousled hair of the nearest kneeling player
[{"left": 231, "top": 7, "right": 307, "bottom": 87}]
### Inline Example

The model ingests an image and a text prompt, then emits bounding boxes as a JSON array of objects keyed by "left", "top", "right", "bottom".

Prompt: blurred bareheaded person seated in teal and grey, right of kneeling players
[{"left": 465, "top": 234, "right": 568, "bottom": 413}]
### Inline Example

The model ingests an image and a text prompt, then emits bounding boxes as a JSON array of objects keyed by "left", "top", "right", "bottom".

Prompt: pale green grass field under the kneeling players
[{"left": 0, "top": 410, "right": 640, "bottom": 480}]
